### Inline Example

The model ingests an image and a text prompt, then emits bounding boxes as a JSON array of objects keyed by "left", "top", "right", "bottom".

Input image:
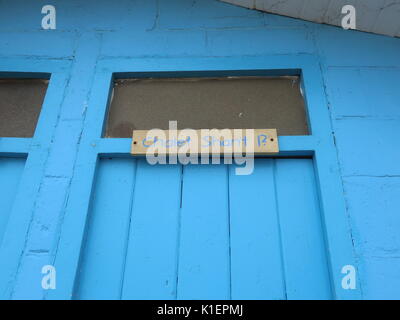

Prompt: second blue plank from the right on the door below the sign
[{"left": 229, "top": 159, "right": 285, "bottom": 300}]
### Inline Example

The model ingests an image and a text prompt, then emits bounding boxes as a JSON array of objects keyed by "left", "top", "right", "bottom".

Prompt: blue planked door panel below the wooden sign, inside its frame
[{"left": 75, "top": 158, "right": 332, "bottom": 299}]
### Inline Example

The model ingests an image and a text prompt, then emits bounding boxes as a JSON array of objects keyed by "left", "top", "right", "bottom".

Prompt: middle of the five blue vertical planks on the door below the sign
[{"left": 178, "top": 165, "right": 230, "bottom": 299}]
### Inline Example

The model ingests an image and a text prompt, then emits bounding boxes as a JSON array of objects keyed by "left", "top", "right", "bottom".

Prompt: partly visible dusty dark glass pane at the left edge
[{"left": 0, "top": 79, "right": 48, "bottom": 138}]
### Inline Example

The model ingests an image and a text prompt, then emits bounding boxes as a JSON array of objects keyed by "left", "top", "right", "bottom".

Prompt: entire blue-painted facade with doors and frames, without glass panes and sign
[{"left": 0, "top": 0, "right": 400, "bottom": 299}]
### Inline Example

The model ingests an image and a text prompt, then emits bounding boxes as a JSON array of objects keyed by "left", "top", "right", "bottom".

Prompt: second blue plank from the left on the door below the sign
[{"left": 122, "top": 159, "right": 182, "bottom": 299}]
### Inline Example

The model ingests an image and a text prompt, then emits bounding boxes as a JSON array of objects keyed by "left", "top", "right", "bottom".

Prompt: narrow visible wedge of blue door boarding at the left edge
[{"left": 0, "top": 158, "right": 25, "bottom": 245}]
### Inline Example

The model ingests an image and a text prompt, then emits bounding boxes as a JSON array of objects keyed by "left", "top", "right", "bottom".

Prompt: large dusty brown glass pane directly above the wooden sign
[{"left": 105, "top": 77, "right": 309, "bottom": 138}]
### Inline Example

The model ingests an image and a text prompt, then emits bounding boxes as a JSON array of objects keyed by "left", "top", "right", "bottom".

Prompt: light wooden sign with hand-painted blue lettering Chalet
[{"left": 131, "top": 129, "right": 279, "bottom": 156}]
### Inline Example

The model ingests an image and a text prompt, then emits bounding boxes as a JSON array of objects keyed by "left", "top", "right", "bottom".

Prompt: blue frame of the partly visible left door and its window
[{"left": 0, "top": 58, "right": 70, "bottom": 299}]
